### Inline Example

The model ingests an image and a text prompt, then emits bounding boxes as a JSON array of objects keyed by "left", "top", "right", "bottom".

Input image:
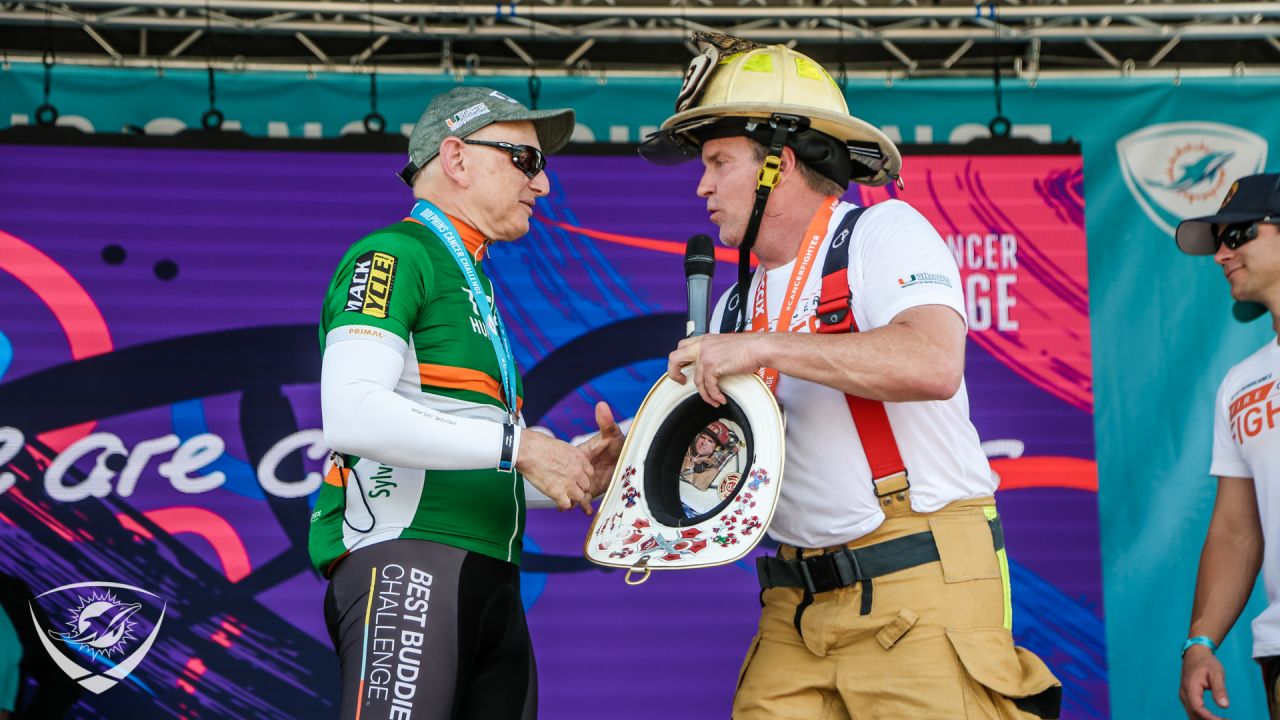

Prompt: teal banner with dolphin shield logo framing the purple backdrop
[{"left": 0, "top": 64, "right": 1280, "bottom": 717}]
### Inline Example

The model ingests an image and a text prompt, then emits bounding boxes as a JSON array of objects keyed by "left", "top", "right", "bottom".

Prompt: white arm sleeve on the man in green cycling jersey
[{"left": 320, "top": 325, "right": 521, "bottom": 470}]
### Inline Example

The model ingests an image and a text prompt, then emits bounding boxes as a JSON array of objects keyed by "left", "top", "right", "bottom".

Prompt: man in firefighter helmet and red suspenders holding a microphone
[{"left": 641, "top": 33, "right": 1061, "bottom": 720}]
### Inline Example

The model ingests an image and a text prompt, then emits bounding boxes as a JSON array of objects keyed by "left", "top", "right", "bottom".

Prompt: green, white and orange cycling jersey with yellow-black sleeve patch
[{"left": 308, "top": 219, "right": 525, "bottom": 575}]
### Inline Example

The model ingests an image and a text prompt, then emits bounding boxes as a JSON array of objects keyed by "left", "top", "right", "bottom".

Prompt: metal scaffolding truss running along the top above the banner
[{"left": 0, "top": 0, "right": 1280, "bottom": 78}]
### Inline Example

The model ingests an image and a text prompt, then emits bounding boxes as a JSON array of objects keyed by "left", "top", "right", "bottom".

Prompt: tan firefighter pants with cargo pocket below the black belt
[{"left": 733, "top": 497, "right": 1061, "bottom": 720}]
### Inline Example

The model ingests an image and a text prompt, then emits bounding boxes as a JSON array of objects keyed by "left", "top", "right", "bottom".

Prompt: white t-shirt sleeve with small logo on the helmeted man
[{"left": 849, "top": 200, "right": 968, "bottom": 329}]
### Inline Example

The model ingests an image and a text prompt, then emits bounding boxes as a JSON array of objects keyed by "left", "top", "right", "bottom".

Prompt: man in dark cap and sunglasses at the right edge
[{"left": 1176, "top": 173, "right": 1280, "bottom": 720}]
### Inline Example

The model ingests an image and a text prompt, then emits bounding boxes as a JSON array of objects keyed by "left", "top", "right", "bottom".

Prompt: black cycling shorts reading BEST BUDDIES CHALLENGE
[{"left": 324, "top": 539, "right": 538, "bottom": 720}]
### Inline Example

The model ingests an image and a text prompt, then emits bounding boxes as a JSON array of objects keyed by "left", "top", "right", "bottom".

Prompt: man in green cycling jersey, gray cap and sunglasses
[{"left": 310, "top": 87, "right": 622, "bottom": 720}]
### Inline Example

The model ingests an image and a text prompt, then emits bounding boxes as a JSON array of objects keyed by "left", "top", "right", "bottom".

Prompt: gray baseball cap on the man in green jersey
[{"left": 401, "top": 86, "right": 573, "bottom": 186}]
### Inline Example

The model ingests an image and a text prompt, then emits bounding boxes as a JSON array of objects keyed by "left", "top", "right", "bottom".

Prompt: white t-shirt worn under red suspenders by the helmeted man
[{"left": 712, "top": 200, "right": 996, "bottom": 547}]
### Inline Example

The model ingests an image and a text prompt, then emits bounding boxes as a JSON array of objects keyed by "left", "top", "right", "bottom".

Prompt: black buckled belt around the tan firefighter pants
[{"left": 755, "top": 518, "right": 1005, "bottom": 594}]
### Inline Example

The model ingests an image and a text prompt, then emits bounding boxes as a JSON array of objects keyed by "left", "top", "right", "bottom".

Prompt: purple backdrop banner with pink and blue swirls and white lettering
[{"left": 0, "top": 137, "right": 1108, "bottom": 719}]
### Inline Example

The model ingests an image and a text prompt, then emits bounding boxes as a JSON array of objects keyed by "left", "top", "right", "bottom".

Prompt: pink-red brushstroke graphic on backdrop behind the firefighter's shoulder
[{"left": 861, "top": 156, "right": 1093, "bottom": 411}]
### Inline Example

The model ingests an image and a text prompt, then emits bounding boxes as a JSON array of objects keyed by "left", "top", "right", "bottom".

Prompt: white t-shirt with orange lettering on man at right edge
[{"left": 1208, "top": 338, "right": 1280, "bottom": 657}]
